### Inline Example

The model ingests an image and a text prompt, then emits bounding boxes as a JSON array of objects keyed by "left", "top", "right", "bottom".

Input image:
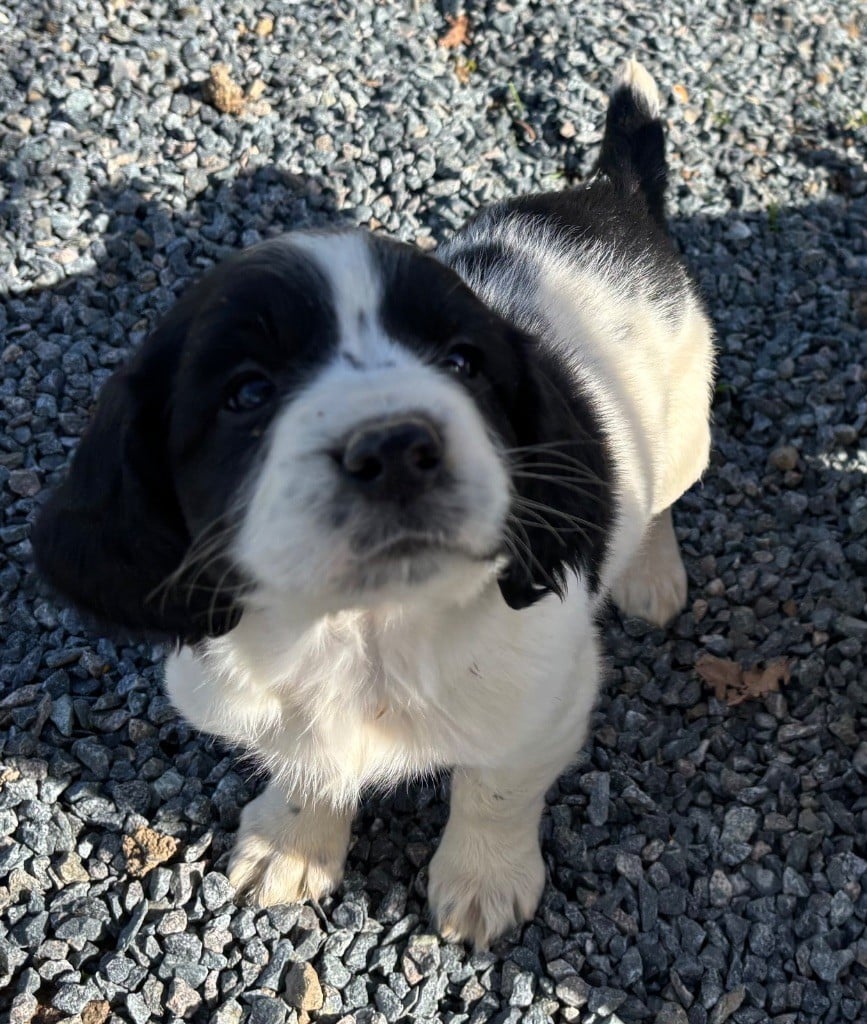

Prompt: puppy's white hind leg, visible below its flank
[{"left": 611, "top": 508, "right": 687, "bottom": 626}]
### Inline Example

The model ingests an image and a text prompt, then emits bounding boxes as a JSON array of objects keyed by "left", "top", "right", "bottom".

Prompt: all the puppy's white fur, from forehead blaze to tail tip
[{"left": 160, "top": 63, "right": 712, "bottom": 945}]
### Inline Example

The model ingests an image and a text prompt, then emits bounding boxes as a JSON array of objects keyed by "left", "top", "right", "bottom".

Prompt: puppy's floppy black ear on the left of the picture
[{"left": 32, "top": 315, "right": 240, "bottom": 642}]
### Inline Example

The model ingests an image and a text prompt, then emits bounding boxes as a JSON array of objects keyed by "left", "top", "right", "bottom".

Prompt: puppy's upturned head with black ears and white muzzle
[{"left": 34, "top": 232, "right": 607, "bottom": 641}]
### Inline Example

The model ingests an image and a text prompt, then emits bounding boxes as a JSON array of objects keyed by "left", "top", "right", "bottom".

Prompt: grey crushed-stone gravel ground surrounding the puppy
[{"left": 0, "top": 0, "right": 867, "bottom": 1024}]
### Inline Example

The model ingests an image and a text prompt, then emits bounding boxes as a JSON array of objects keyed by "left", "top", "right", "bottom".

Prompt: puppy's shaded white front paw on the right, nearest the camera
[{"left": 428, "top": 825, "right": 545, "bottom": 949}]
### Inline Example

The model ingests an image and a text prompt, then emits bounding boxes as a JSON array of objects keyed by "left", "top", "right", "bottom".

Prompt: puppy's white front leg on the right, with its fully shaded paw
[{"left": 428, "top": 762, "right": 565, "bottom": 949}]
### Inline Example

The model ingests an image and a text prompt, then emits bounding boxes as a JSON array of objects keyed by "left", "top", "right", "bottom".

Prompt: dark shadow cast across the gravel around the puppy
[{"left": 0, "top": 165, "right": 867, "bottom": 1021}]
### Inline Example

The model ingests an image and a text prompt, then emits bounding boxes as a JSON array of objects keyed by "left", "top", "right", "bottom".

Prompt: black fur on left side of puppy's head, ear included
[{"left": 32, "top": 246, "right": 336, "bottom": 642}]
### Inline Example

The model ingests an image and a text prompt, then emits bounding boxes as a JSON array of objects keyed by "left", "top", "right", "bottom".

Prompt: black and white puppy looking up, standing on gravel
[{"left": 34, "top": 60, "right": 712, "bottom": 945}]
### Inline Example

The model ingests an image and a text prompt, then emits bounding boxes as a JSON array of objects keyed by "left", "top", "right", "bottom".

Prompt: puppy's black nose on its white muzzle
[{"left": 340, "top": 419, "right": 442, "bottom": 497}]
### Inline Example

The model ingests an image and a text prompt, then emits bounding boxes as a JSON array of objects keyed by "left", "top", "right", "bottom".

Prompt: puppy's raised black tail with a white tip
[{"left": 597, "top": 57, "right": 667, "bottom": 226}]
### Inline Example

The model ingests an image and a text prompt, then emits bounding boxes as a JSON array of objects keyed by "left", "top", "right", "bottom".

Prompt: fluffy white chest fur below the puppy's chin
[{"left": 166, "top": 581, "right": 598, "bottom": 805}]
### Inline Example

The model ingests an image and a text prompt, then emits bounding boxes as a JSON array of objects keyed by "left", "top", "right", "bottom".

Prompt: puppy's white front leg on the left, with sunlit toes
[{"left": 228, "top": 781, "right": 352, "bottom": 906}]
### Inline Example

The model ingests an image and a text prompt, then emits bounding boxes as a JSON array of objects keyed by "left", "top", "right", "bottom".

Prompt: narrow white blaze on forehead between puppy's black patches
[{"left": 292, "top": 231, "right": 394, "bottom": 367}]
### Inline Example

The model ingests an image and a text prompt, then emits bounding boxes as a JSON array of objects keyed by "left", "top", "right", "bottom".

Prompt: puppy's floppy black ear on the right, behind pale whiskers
[{"left": 500, "top": 338, "right": 614, "bottom": 609}]
